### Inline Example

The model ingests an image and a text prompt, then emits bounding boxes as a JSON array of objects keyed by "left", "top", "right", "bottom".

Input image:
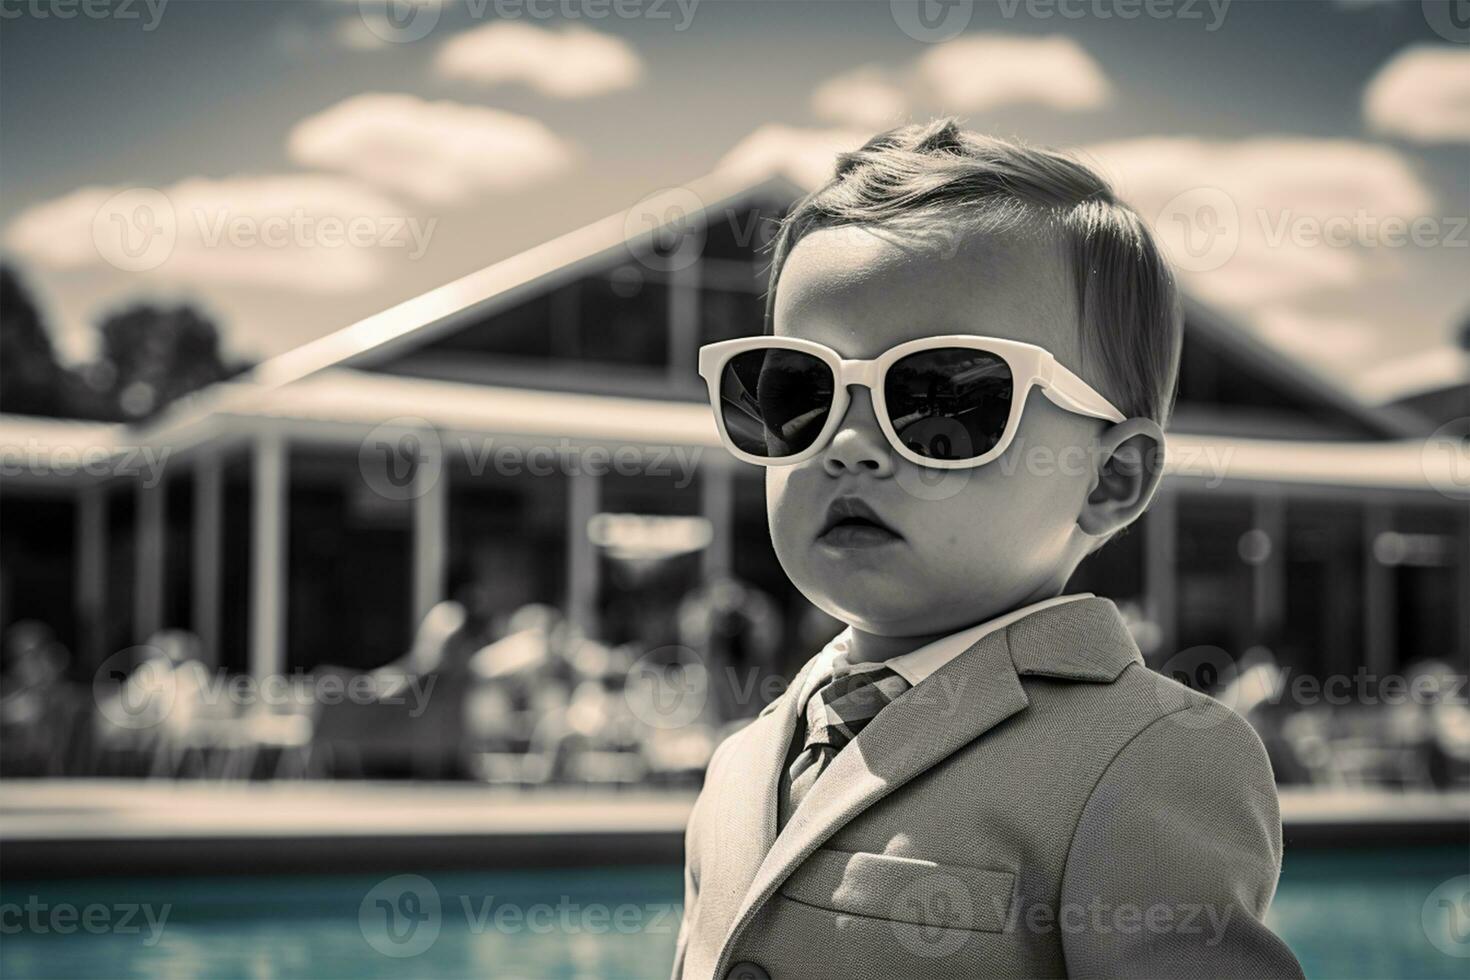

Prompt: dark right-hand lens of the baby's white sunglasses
[{"left": 883, "top": 347, "right": 1016, "bottom": 460}]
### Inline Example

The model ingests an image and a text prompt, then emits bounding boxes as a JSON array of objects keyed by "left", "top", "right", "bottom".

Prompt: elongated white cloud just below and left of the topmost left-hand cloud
[{"left": 287, "top": 93, "right": 573, "bottom": 206}]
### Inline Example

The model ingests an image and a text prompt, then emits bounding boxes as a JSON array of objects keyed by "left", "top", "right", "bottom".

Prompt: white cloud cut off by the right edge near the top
[{"left": 1363, "top": 44, "right": 1470, "bottom": 143}]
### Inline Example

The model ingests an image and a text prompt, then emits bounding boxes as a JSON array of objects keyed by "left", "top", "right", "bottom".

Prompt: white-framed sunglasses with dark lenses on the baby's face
[{"left": 700, "top": 334, "right": 1126, "bottom": 470}]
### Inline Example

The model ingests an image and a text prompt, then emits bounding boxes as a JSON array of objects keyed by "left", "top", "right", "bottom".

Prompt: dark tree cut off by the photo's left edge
[{"left": 0, "top": 264, "right": 72, "bottom": 416}]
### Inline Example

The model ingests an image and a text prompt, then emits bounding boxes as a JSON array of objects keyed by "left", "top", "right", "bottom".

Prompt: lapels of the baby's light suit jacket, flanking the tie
[{"left": 714, "top": 630, "right": 1028, "bottom": 976}]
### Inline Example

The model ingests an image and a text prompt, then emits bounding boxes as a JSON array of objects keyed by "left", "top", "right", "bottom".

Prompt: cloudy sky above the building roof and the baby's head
[{"left": 0, "top": 0, "right": 1470, "bottom": 401}]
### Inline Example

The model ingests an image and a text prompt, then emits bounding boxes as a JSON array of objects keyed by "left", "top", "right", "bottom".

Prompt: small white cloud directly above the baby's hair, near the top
[{"left": 914, "top": 34, "right": 1111, "bottom": 113}]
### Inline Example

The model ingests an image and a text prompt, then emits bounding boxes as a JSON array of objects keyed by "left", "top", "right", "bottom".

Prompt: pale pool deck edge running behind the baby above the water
[{"left": 0, "top": 780, "right": 1470, "bottom": 879}]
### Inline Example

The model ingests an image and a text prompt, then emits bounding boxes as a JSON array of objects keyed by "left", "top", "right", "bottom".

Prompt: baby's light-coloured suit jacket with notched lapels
[{"left": 673, "top": 599, "right": 1302, "bottom": 980}]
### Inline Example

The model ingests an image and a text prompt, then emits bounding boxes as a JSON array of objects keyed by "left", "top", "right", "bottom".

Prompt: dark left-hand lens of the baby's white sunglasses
[{"left": 720, "top": 347, "right": 832, "bottom": 460}]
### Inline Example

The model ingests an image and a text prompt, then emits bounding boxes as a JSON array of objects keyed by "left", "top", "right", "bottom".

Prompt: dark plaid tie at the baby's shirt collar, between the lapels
[{"left": 789, "top": 660, "right": 908, "bottom": 811}]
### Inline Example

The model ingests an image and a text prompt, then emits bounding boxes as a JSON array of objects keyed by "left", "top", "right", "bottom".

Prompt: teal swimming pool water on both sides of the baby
[{"left": 0, "top": 848, "right": 1470, "bottom": 980}]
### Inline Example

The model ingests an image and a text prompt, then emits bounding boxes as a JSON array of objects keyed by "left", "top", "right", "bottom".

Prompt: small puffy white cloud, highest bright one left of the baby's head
[{"left": 434, "top": 21, "right": 644, "bottom": 98}]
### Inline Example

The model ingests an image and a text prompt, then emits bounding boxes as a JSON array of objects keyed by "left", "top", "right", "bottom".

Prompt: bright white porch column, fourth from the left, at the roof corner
[{"left": 250, "top": 432, "right": 288, "bottom": 685}]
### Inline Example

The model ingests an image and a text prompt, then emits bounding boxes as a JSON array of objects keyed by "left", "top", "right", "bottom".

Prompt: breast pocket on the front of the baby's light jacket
[{"left": 781, "top": 848, "right": 1016, "bottom": 933}]
